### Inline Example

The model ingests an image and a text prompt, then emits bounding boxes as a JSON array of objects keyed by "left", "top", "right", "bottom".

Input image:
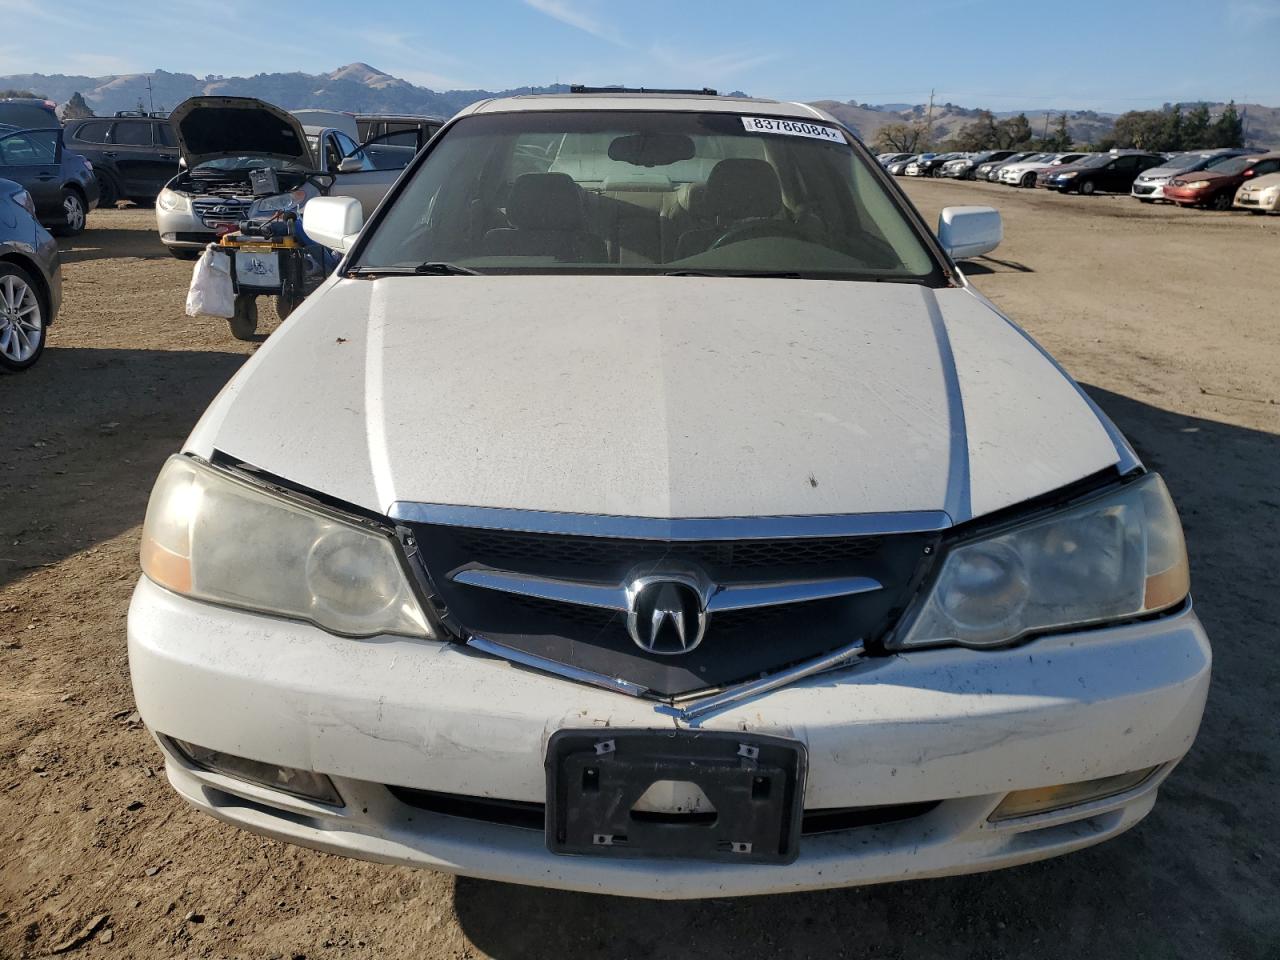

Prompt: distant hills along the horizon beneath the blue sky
[{"left": 0, "top": 63, "right": 1280, "bottom": 147}]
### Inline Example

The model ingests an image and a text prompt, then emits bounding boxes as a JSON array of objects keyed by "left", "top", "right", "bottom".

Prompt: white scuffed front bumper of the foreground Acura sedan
[{"left": 128, "top": 579, "right": 1210, "bottom": 897}]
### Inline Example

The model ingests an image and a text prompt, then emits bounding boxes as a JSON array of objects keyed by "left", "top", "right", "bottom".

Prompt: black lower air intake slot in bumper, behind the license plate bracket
[{"left": 387, "top": 786, "right": 938, "bottom": 836}]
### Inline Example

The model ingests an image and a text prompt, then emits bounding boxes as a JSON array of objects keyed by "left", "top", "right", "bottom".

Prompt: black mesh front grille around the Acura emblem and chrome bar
[{"left": 413, "top": 524, "right": 937, "bottom": 695}]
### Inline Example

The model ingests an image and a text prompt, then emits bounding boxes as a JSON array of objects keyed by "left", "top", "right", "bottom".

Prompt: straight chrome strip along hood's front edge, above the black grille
[{"left": 387, "top": 500, "right": 954, "bottom": 541}]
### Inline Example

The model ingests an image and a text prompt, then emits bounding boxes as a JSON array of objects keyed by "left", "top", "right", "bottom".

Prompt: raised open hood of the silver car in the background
[{"left": 169, "top": 97, "right": 315, "bottom": 169}]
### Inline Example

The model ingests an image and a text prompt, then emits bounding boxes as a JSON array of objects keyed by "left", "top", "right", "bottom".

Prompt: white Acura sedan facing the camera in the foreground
[{"left": 128, "top": 90, "right": 1210, "bottom": 897}]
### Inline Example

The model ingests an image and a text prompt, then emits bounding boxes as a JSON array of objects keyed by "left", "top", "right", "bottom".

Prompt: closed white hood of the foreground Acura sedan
[{"left": 187, "top": 276, "right": 1120, "bottom": 522}]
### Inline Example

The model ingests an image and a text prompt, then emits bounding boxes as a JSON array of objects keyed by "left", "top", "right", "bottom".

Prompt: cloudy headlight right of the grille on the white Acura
[{"left": 888, "top": 474, "right": 1190, "bottom": 649}]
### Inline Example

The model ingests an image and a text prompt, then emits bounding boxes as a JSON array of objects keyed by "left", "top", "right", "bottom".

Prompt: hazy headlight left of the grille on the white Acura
[{"left": 142, "top": 456, "right": 433, "bottom": 637}]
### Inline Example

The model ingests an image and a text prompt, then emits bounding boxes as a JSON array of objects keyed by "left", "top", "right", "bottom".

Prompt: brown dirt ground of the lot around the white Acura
[{"left": 0, "top": 182, "right": 1280, "bottom": 960}]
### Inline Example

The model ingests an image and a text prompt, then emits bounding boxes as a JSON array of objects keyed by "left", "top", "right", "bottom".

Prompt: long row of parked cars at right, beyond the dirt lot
[{"left": 878, "top": 148, "right": 1280, "bottom": 214}]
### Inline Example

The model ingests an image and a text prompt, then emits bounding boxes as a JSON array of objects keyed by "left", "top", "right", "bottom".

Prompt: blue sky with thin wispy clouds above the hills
[{"left": 0, "top": 0, "right": 1280, "bottom": 111}]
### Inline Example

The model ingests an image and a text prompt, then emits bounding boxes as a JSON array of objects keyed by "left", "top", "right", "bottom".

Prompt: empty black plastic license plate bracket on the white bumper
[{"left": 547, "top": 728, "right": 808, "bottom": 864}]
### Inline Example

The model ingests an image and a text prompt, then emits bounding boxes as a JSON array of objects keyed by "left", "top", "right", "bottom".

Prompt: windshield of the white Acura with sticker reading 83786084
[{"left": 355, "top": 110, "right": 941, "bottom": 280}]
